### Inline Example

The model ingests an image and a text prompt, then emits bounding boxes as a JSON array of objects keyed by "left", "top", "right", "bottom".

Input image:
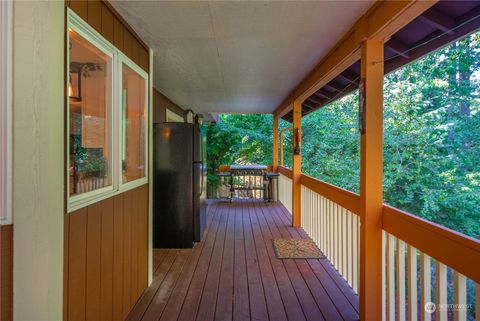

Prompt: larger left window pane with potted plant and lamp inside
[{"left": 69, "top": 30, "right": 112, "bottom": 195}]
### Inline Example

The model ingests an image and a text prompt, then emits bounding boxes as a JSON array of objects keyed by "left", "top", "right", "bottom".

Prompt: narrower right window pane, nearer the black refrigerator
[{"left": 122, "top": 64, "right": 146, "bottom": 183}]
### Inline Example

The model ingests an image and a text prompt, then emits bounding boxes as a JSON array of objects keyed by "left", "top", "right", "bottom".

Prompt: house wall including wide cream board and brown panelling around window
[{"left": 9, "top": 1, "right": 151, "bottom": 320}]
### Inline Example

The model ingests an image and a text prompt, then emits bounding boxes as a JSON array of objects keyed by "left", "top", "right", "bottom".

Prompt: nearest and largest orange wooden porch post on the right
[{"left": 359, "top": 40, "right": 383, "bottom": 321}]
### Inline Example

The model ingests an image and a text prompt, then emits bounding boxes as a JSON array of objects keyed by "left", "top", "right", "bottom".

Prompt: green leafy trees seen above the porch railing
[{"left": 208, "top": 32, "right": 480, "bottom": 238}]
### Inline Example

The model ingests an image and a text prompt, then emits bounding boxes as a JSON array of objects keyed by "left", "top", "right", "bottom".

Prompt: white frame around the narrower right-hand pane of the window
[{"left": 117, "top": 53, "right": 149, "bottom": 192}]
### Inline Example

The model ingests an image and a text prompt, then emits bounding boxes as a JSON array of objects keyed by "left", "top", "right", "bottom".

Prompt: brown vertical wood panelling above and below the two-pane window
[{"left": 63, "top": 0, "right": 151, "bottom": 321}]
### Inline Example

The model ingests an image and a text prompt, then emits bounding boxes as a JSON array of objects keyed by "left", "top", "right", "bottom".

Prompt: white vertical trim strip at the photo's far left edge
[{"left": 0, "top": 1, "right": 13, "bottom": 225}]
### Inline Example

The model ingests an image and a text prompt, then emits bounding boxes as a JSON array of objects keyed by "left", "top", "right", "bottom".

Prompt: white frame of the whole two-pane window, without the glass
[{"left": 65, "top": 8, "right": 150, "bottom": 213}]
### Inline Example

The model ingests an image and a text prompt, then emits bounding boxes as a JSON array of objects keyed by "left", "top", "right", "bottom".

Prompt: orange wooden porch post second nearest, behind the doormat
[{"left": 292, "top": 100, "right": 302, "bottom": 227}]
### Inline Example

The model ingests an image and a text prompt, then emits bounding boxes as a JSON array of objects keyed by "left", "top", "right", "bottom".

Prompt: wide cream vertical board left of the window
[{"left": 12, "top": 1, "right": 65, "bottom": 320}]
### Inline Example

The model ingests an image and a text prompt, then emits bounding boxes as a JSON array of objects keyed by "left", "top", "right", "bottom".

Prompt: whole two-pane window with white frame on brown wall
[{"left": 66, "top": 10, "right": 148, "bottom": 211}]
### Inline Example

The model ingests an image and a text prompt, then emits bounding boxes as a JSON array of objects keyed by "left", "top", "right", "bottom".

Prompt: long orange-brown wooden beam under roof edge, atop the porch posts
[{"left": 273, "top": 0, "right": 437, "bottom": 117}]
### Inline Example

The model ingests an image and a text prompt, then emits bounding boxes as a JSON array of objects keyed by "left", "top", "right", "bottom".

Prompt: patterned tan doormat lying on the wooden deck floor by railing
[{"left": 272, "top": 239, "right": 323, "bottom": 259}]
